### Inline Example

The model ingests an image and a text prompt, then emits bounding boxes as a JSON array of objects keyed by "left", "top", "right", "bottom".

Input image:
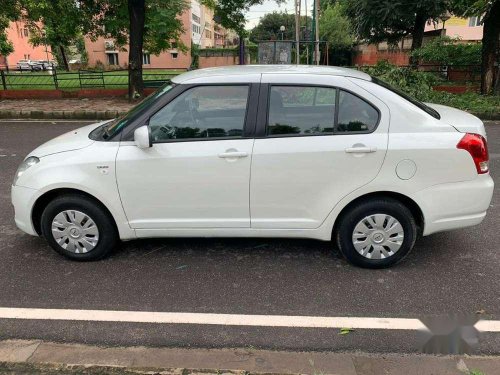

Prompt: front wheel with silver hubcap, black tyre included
[{"left": 41, "top": 194, "right": 118, "bottom": 261}]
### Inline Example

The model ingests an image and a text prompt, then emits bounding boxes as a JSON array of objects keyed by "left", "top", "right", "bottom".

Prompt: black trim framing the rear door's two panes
[{"left": 255, "top": 83, "right": 382, "bottom": 139}]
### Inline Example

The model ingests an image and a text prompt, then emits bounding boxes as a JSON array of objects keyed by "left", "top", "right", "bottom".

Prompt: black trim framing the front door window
[{"left": 145, "top": 83, "right": 258, "bottom": 146}]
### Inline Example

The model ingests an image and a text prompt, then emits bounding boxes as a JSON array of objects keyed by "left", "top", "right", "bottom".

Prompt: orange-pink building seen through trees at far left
[{"left": 0, "top": 21, "right": 53, "bottom": 69}]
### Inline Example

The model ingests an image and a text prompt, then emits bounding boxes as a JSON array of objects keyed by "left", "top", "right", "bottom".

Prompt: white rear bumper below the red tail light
[{"left": 412, "top": 174, "right": 494, "bottom": 236}]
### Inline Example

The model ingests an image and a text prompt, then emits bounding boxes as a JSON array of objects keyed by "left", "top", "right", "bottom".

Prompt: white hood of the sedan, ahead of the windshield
[{"left": 29, "top": 122, "right": 104, "bottom": 158}]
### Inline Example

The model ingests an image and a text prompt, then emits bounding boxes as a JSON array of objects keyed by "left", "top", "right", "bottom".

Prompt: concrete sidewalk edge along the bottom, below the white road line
[{"left": 0, "top": 340, "right": 500, "bottom": 375}]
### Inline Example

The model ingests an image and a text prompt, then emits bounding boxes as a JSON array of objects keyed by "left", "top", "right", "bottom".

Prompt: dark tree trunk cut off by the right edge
[{"left": 481, "top": 1, "right": 500, "bottom": 95}]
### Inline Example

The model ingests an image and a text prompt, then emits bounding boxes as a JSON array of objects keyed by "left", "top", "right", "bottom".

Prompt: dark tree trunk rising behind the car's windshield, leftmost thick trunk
[{"left": 128, "top": 0, "right": 146, "bottom": 101}]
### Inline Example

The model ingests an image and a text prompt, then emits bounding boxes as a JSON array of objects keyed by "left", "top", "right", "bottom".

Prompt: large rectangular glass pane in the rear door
[{"left": 267, "top": 86, "right": 337, "bottom": 135}]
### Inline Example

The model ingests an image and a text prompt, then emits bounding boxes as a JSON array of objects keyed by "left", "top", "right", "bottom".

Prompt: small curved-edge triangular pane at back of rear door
[{"left": 337, "top": 90, "right": 378, "bottom": 132}]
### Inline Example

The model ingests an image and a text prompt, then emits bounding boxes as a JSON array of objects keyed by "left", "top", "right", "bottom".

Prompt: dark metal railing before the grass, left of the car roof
[{"left": 0, "top": 69, "right": 185, "bottom": 90}]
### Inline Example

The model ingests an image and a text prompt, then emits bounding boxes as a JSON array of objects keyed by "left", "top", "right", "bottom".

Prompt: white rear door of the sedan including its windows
[{"left": 250, "top": 74, "right": 389, "bottom": 229}]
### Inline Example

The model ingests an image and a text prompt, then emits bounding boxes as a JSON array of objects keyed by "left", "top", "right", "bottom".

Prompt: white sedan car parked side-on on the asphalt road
[{"left": 12, "top": 65, "right": 493, "bottom": 268}]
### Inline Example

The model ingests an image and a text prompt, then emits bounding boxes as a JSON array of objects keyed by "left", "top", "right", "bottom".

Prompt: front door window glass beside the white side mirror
[{"left": 149, "top": 85, "right": 249, "bottom": 142}]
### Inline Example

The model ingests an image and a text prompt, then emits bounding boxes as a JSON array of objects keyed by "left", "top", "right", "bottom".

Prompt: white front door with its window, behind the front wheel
[{"left": 116, "top": 84, "right": 254, "bottom": 229}]
